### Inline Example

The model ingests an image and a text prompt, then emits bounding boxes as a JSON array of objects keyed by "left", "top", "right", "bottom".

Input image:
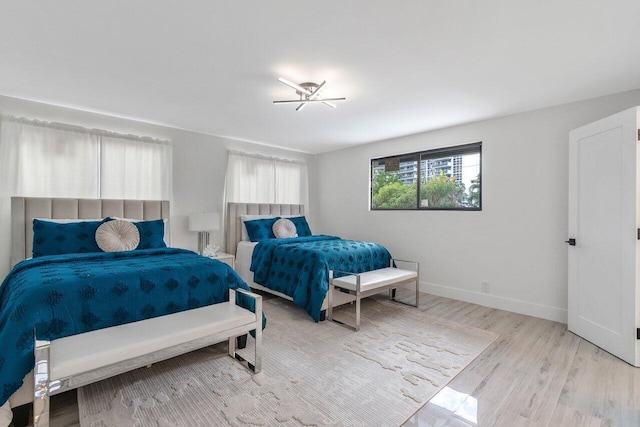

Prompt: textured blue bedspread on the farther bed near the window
[{"left": 251, "top": 236, "right": 391, "bottom": 322}]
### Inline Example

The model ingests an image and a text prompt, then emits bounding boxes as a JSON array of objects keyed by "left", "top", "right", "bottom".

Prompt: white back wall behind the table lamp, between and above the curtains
[{"left": 0, "top": 96, "right": 311, "bottom": 270}]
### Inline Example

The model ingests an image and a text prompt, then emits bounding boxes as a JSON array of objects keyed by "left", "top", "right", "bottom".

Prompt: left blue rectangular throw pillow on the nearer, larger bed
[{"left": 33, "top": 218, "right": 111, "bottom": 258}]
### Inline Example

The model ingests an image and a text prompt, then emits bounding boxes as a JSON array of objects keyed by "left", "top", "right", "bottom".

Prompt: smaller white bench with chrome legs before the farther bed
[{"left": 327, "top": 260, "right": 420, "bottom": 331}]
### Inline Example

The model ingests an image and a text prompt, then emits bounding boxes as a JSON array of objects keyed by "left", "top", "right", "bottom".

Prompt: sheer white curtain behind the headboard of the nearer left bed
[{"left": 0, "top": 115, "right": 172, "bottom": 277}]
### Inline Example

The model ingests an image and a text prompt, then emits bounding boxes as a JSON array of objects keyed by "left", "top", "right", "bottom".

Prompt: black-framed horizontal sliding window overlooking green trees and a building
[{"left": 370, "top": 142, "right": 482, "bottom": 211}]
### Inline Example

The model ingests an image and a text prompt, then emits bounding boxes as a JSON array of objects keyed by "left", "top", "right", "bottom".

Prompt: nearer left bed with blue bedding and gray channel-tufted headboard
[{"left": 0, "top": 198, "right": 264, "bottom": 410}]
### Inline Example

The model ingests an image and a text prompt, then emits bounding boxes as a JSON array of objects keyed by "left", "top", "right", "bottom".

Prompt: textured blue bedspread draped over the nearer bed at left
[{"left": 0, "top": 248, "right": 253, "bottom": 405}]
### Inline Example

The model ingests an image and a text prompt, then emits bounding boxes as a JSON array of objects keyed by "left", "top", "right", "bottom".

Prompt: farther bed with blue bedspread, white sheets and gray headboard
[{"left": 227, "top": 203, "right": 391, "bottom": 321}]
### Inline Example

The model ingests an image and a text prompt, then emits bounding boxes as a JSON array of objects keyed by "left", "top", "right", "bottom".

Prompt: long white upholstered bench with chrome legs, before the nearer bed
[{"left": 33, "top": 289, "right": 262, "bottom": 427}]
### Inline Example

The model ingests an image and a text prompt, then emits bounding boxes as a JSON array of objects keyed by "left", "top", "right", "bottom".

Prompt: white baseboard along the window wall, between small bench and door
[{"left": 420, "top": 282, "right": 568, "bottom": 324}]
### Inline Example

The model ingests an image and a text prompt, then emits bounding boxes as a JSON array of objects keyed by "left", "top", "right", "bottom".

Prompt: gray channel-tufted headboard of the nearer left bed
[{"left": 11, "top": 197, "right": 169, "bottom": 266}]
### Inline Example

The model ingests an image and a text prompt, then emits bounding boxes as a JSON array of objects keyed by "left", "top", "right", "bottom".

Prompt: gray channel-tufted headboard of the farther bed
[{"left": 226, "top": 202, "right": 304, "bottom": 255}]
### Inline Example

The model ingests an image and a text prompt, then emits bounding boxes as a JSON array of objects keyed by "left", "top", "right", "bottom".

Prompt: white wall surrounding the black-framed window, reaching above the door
[{"left": 310, "top": 90, "right": 640, "bottom": 323}]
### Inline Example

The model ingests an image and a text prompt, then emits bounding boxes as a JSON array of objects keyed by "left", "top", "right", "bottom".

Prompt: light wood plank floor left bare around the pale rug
[{"left": 17, "top": 294, "right": 640, "bottom": 427}]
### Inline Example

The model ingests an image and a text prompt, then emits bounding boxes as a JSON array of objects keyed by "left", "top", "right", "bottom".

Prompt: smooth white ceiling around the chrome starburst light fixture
[{"left": 0, "top": 0, "right": 640, "bottom": 153}]
